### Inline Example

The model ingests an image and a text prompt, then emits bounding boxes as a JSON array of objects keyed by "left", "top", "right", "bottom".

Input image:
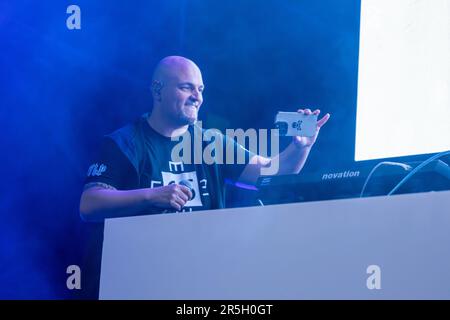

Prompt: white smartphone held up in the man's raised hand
[{"left": 275, "top": 111, "right": 317, "bottom": 137}]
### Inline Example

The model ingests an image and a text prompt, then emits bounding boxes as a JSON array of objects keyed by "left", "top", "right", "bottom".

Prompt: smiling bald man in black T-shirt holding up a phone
[{"left": 80, "top": 56, "right": 330, "bottom": 221}]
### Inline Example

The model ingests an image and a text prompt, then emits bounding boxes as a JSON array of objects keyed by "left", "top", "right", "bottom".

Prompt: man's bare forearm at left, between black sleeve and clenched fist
[{"left": 80, "top": 187, "right": 150, "bottom": 221}]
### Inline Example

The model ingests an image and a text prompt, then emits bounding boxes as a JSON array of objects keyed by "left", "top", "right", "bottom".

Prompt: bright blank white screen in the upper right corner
[{"left": 355, "top": 0, "right": 450, "bottom": 161}]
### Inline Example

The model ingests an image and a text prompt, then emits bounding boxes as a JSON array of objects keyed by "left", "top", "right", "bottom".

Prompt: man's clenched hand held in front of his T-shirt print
[{"left": 148, "top": 183, "right": 192, "bottom": 211}]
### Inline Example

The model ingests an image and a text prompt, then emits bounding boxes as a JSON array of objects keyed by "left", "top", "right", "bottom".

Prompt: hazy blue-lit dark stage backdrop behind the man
[{"left": 0, "top": 0, "right": 360, "bottom": 299}]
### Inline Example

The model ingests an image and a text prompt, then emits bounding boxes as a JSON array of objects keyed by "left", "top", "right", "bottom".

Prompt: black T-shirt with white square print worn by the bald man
[{"left": 86, "top": 115, "right": 252, "bottom": 214}]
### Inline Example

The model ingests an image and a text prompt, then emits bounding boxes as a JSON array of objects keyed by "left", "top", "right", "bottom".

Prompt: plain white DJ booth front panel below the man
[{"left": 100, "top": 191, "right": 450, "bottom": 299}]
